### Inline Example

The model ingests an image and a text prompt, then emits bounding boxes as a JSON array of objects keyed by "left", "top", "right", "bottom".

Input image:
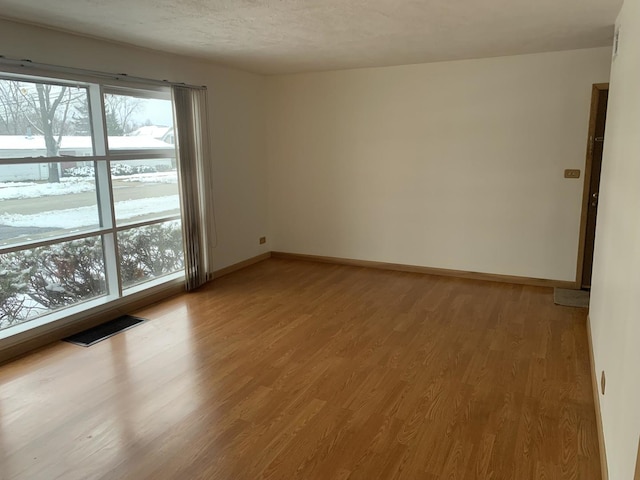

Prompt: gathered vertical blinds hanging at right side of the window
[{"left": 173, "top": 85, "right": 213, "bottom": 290}]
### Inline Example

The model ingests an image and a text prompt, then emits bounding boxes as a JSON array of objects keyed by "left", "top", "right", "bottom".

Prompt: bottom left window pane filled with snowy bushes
[{"left": 0, "top": 236, "right": 107, "bottom": 330}]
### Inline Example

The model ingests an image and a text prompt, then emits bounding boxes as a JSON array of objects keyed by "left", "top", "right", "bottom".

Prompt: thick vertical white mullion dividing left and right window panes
[{"left": 89, "top": 85, "right": 122, "bottom": 297}]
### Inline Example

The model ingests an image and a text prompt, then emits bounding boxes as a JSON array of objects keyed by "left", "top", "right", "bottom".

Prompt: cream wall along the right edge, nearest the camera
[{"left": 589, "top": 0, "right": 640, "bottom": 480}]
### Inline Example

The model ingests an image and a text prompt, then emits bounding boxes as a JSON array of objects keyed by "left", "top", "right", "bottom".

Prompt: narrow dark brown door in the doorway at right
[{"left": 576, "top": 83, "right": 609, "bottom": 289}]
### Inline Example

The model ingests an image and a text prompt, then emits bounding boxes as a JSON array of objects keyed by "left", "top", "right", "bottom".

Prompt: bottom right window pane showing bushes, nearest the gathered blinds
[{"left": 118, "top": 220, "right": 184, "bottom": 288}]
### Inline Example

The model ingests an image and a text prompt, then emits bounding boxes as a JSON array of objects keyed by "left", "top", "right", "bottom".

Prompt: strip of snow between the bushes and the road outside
[{"left": 0, "top": 195, "right": 180, "bottom": 229}]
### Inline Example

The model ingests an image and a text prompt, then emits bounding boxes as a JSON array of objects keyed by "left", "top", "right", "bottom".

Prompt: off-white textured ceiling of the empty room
[{"left": 0, "top": 0, "right": 621, "bottom": 74}]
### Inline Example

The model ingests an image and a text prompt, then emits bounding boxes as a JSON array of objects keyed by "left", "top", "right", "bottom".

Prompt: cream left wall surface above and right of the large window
[{"left": 0, "top": 20, "right": 269, "bottom": 269}]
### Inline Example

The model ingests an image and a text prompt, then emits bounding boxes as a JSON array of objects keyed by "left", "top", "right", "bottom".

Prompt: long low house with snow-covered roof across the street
[{"left": 0, "top": 134, "right": 173, "bottom": 182}]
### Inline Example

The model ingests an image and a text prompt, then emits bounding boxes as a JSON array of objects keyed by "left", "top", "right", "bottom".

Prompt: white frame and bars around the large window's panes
[{"left": 0, "top": 70, "right": 184, "bottom": 339}]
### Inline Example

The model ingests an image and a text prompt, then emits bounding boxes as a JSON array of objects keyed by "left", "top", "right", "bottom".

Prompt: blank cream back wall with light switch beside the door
[{"left": 267, "top": 48, "right": 610, "bottom": 281}]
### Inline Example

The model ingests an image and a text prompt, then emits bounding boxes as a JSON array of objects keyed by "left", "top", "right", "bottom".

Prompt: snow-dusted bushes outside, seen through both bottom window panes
[{"left": 0, "top": 221, "right": 184, "bottom": 330}]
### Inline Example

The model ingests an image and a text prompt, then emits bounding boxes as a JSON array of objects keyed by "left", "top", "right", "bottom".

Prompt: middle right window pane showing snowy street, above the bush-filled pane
[{"left": 111, "top": 158, "right": 180, "bottom": 225}]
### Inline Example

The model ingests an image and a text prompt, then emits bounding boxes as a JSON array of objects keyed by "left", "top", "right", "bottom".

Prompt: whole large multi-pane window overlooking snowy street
[{"left": 0, "top": 74, "right": 184, "bottom": 336}]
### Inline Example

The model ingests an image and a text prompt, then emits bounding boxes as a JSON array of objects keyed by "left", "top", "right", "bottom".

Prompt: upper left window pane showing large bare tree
[{"left": 0, "top": 79, "right": 93, "bottom": 159}]
